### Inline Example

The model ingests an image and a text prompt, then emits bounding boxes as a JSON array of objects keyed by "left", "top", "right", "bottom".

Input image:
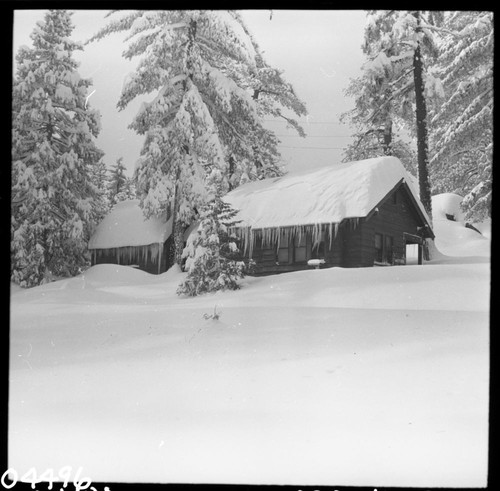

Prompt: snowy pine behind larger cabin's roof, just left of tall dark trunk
[{"left": 341, "top": 11, "right": 424, "bottom": 176}]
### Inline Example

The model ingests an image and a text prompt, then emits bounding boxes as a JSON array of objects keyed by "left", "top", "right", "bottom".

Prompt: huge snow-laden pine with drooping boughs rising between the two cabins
[{"left": 89, "top": 10, "right": 305, "bottom": 263}]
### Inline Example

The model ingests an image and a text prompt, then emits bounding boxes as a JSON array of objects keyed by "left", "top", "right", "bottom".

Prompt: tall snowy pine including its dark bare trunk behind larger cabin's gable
[{"left": 342, "top": 10, "right": 442, "bottom": 222}]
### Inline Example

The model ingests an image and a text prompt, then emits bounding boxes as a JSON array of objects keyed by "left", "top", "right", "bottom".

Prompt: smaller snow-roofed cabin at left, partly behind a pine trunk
[{"left": 89, "top": 200, "right": 172, "bottom": 274}]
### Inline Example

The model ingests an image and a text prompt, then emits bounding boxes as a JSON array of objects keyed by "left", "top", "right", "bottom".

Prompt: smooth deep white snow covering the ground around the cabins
[{"left": 8, "top": 196, "right": 490, "bottom": 489}]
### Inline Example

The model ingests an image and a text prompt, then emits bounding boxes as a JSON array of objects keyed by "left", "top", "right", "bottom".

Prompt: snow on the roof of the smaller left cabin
[{"left": 89, "top": 200, "right": 172, "bottom": 249}]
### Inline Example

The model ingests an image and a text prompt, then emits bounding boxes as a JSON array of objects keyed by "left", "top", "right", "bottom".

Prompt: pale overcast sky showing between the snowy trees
[{"left": 13, "top": 10, "right": 365, "bottom": 175}]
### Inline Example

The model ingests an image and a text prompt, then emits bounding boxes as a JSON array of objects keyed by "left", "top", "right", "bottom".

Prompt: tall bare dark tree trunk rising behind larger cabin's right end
[{"left": 413, "top": 12, "right": 432, "bottom": 220}]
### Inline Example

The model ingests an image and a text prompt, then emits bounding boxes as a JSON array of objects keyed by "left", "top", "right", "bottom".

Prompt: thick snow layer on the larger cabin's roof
[{"left": 225, "top": 157, "right": 430, "bottom": 229}]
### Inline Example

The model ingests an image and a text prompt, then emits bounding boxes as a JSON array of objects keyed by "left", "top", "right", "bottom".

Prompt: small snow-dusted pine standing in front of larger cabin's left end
[{"left": 177, "top": 169, "right": 245, "bottom": 296}]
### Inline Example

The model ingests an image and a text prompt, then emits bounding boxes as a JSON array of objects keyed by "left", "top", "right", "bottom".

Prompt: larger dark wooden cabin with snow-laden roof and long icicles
[{"left": 225, "top": 157, "right": 434, "bottom": 274}]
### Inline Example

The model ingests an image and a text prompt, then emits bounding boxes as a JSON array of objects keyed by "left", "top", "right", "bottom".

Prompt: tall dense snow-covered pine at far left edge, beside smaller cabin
[{"left": 11, "top": 10, "right": 102, "bottom": 286}]
